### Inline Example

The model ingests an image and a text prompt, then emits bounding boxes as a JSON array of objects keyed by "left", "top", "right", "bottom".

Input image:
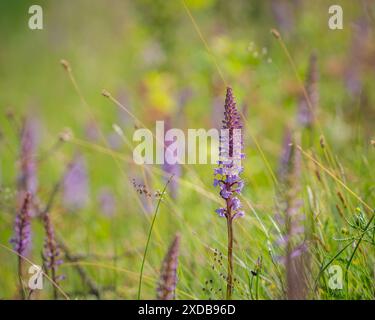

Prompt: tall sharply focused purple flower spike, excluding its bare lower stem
[{"left": 214, "top": 87, "right": 244, "bottom": 220}]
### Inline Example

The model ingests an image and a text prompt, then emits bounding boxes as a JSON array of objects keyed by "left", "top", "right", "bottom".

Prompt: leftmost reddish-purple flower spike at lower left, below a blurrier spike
[{"left": 10, "top": 192, "right": 31, "bottom": 256}]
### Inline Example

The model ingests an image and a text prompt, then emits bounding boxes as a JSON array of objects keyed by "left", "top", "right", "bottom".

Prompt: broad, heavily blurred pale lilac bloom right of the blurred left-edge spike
[{"left": 63, "top": 156, "right": 89, "bottom": 210}]
